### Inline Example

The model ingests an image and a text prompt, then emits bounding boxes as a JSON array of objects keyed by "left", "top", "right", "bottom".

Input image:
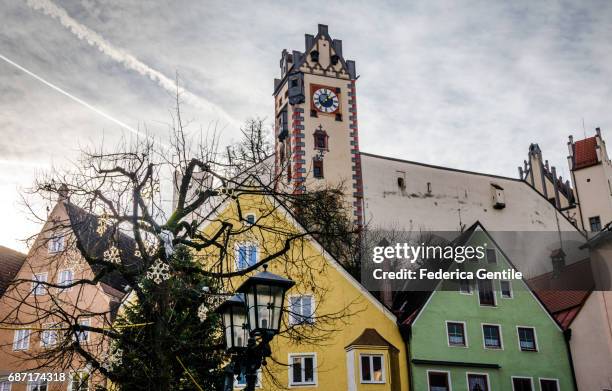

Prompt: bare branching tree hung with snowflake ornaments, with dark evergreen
[{"left": 0, "top": 96, "right": 360, "bottom": 390}]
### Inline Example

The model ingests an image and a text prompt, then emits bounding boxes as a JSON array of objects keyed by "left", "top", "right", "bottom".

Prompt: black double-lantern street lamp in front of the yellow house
[{"left": 216, "top": 265, "right": 295, "bottom": 391}]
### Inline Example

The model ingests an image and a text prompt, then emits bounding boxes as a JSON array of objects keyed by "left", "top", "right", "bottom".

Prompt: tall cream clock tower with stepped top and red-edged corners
[{"left": 274, "top": 24, "right": 363, "bottom": 224}]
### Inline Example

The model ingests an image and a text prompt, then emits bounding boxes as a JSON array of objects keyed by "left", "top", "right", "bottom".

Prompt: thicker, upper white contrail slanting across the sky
[{"left": 27, "top": 0, "right": 236, "bottom": 124}]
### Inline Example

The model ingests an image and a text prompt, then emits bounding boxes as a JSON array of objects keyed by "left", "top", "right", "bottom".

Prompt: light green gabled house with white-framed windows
[{"left": 402, "top": 223, "right": 576, "bottom": 391}]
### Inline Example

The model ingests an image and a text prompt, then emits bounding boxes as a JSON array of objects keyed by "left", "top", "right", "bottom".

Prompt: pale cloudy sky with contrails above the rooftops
[{"left": 0, "top": 0, "right": 612, "bottom": 251}]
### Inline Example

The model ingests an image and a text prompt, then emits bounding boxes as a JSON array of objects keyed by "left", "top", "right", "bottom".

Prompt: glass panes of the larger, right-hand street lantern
[{"left": 246, "top": 283, "right": 285, "bottom": 333}]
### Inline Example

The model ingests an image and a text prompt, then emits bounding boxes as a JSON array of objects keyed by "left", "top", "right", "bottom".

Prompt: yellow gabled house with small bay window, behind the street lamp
[{"left": 203, "top": 188, "right": 409, "bottom": 391}]
